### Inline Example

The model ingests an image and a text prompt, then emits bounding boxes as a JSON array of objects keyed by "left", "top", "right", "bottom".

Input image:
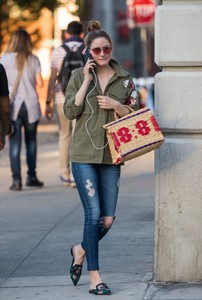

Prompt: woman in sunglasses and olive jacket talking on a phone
[{"left": 64, "top": 21, "right": 138, "bottom": 295}]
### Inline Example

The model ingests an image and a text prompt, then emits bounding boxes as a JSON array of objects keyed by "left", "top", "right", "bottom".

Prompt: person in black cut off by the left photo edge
[{"left": 0, "top": 64, "right": 10, "bottom": 150}]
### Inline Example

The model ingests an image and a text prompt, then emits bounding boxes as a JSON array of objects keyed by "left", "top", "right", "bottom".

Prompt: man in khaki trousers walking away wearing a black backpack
[{"left": 46, "top": 21, "right": 84, "bottom": 187}]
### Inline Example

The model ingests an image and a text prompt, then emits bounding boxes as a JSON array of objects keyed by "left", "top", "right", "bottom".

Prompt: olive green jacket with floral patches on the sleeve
[{"left": 64, "top": 59, "right": 137, "bottom": 164}]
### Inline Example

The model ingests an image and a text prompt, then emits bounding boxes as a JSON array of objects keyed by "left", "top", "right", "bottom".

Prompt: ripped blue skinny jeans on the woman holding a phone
[{"left": 72, "top": 162, "right": 121, "bottom": 271}]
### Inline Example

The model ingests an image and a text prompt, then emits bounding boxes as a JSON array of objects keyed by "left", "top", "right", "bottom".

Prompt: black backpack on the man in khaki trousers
[{"left": 58, "top": 44, "right": 84, "bottom": 95}]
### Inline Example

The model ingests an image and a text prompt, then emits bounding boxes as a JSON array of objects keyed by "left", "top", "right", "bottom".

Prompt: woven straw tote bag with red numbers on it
[{"left": 103, "top": 107, "right": 164, "bottom": 165}]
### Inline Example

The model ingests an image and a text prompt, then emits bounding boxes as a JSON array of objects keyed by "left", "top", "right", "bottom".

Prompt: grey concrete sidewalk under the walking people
[{"left": 0, "top": 120, "right": 202, "bottom": 300}]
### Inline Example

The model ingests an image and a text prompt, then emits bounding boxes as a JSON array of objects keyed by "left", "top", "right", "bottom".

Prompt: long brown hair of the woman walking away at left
[{"left": 7, "top": 29, "right": 32, "bottom": 71}]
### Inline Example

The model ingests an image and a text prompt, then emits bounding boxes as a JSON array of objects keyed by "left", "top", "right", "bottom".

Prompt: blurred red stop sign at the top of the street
[{"left": 127, "top": 0, "right": 157, "bottom": 27}]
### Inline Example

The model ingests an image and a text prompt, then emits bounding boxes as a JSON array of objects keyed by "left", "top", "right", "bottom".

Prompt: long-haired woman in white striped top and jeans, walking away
[{"left": 0, "top": 29, "right": 43, "bottom": 191}]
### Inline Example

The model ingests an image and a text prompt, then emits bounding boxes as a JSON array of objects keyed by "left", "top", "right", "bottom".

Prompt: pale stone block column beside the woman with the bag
[{"left": 154, "top": 0, "right": 202, "bottom": 282}]
